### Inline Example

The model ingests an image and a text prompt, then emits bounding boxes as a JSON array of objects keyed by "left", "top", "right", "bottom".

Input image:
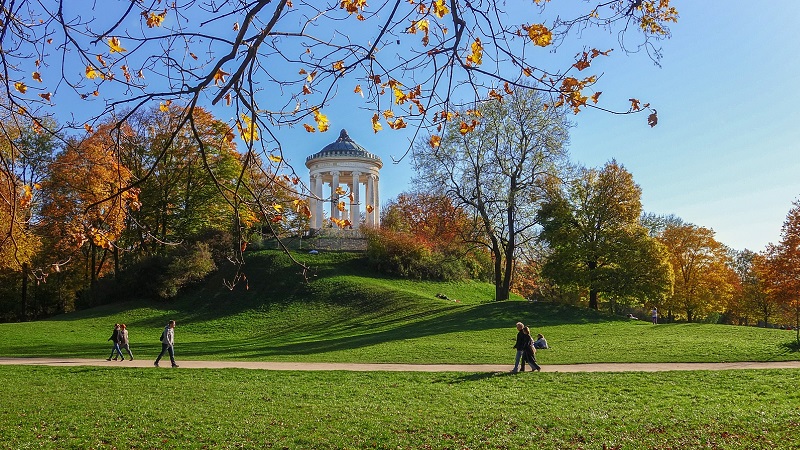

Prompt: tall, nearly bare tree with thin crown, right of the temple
[{"left": 414, "top": 90, "right": 569, "bottom": 300}]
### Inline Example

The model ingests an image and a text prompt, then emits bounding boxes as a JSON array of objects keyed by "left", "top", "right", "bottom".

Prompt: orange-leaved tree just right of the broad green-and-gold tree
[{"left": 660, "top": 224, "right": 735, "bottom": 322}]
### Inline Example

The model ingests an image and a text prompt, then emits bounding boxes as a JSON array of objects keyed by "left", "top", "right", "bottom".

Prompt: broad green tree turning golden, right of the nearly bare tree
[{"left": 538, "top": 161, "right": 672, "bottom": 309}]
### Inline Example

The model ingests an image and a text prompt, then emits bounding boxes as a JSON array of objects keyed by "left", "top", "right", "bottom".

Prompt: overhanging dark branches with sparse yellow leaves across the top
[{"left": 0, "top": 0, "right": 678, "bottom": 278}]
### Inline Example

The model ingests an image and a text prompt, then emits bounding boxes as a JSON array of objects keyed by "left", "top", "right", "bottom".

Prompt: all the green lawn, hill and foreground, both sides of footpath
[{"left": 0, "top": 252, "right": 800, "bottom": 449}]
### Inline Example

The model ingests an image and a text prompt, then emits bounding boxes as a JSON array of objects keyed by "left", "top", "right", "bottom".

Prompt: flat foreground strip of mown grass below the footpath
[{"left": 0, "top": 366, "right": 800, "bottom": 449}]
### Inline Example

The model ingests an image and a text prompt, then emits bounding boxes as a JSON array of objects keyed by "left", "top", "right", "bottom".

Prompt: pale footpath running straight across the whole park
[{"left": 0, "top": 357, "right": 800, "bottom": 373}]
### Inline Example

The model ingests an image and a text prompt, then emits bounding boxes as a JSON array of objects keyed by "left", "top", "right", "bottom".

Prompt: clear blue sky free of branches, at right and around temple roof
[{"left": 296, "top": 0, "right": 800, "bottom": 251}]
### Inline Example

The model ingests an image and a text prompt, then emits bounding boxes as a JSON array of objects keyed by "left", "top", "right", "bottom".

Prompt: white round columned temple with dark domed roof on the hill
[{"left": 306, "top": 130, "right": 383, "bottom": 229}]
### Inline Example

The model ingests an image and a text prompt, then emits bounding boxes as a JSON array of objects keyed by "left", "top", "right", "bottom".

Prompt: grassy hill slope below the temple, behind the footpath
[{"left": 0, "top": 251, "right": 800, "bottom": 364}]
